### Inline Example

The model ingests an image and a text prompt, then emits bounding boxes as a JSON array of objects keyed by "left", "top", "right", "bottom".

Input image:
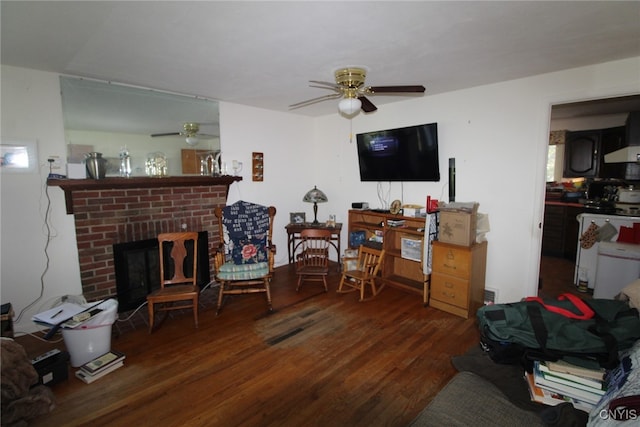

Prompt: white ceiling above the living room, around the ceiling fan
[{"left": 1, "top": 1, "right": 640, "bottom": 122}]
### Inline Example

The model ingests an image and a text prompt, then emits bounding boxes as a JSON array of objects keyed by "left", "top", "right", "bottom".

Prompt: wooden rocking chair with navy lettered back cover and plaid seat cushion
[{"left": 213, "top": 201, "right": 276, "bottom": 316}]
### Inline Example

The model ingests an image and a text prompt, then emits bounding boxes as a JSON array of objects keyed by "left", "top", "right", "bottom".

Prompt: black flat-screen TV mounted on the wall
[{"left": 356, "top": 123, "right": 440, "bottom": 181}]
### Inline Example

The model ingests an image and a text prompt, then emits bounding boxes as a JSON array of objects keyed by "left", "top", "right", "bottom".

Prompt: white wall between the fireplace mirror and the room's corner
[{"left": 220, "top": 103, "right": 316, "bottom": 265}]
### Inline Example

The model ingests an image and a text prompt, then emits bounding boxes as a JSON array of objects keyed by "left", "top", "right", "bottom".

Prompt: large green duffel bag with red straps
[{"left": 477, "top": 294, "right": 640, "bottom": 369}]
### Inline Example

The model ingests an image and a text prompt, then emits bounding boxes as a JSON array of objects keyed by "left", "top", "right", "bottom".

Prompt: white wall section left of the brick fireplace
[{"left": 0, "top": 66, "right": 82, "bottom": 331}]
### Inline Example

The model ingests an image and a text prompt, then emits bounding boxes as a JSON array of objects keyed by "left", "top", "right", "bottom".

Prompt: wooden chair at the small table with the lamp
[{"left": 296, "top": 228, "right": 331, "bottom": 292}]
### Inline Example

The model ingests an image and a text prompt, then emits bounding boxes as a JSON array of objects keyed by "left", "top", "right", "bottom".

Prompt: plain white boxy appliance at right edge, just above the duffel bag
[{"left": 593, "top": 242, "right": 640, "bottom": 299}]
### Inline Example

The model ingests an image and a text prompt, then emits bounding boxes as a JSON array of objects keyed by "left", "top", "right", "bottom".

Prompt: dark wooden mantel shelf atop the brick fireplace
[{"left": 47, "top": 175, "right": 242, "bottom": 214}]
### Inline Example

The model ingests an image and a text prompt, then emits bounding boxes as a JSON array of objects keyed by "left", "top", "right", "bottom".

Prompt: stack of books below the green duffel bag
[{"left": 525, "top": 361, "right": 607, "bottom": 412}]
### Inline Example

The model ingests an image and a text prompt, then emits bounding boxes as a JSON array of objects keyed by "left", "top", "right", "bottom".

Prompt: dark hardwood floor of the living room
[{"left": 18, "top": 266, "right": 479, "bottom": 426}]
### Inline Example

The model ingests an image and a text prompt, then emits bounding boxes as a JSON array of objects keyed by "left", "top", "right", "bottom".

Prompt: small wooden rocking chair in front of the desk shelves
[{"left": 338, "top": 245, "right": 384, "bottom": 301}]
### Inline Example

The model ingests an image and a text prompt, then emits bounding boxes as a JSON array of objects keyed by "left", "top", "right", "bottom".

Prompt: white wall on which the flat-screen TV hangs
[{"left": 315, "top": 58, "right": 640, "bottom": 302}]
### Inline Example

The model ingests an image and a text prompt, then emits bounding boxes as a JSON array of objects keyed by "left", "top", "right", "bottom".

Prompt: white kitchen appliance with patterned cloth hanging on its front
[{"left": 573, "top": 213, "right": 640, "bottom": 289}]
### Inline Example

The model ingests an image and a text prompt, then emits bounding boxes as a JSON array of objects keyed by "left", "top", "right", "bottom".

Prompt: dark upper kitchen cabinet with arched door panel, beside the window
[{"left": 562, "top": 130, "right": 601, "bottom": 178}]
